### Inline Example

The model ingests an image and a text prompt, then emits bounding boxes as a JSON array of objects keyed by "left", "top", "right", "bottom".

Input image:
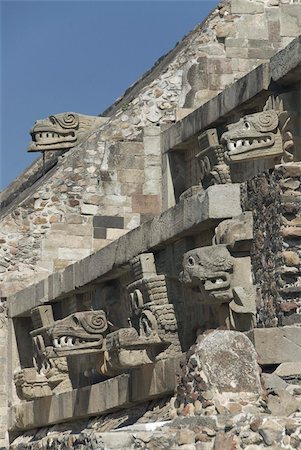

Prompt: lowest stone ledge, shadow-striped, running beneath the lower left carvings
[{"left": 9, "top": 356, "right": 180, "bottom": 431}]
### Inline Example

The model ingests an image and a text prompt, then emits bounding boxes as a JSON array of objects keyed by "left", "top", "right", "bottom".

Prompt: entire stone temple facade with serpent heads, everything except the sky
[{"left": 0, "top": 0, "right": 301, "bottom": 450}]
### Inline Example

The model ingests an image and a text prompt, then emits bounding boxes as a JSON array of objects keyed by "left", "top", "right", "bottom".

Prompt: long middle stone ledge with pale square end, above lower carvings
[{"left": 8, "top": 184, "right": 242, "bottom": 317}]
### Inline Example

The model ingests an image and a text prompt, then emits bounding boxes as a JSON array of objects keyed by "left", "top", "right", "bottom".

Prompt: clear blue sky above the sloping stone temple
[{"left": 0, "top": 0, "right": 213, "bottom": 190}]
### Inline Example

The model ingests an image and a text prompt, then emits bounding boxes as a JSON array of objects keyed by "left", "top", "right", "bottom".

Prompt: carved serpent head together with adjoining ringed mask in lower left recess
[{"left": 14, "top": 253, "right": 182, "bottom": 400}]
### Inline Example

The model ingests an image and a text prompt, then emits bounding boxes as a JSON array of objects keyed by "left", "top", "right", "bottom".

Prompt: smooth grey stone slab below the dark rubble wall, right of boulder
[{"left": 246, "top": 326, "right": 301, "bottom": 365}]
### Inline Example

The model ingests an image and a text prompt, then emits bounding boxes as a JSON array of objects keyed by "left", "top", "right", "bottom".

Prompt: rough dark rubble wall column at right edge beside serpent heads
[{"left": 246, "top": 163, "right": 301, "bottom": 327}]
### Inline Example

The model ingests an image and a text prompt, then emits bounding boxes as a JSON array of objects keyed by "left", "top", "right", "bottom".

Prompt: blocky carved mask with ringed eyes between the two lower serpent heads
[{"left": 101, "top": 253, "right": 181, "bottom": 376}]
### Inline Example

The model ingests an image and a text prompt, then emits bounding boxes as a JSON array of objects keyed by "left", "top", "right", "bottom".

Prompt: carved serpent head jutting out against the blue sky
[{"left": 28, "top": 112, "right": 106, "bottom": 152}]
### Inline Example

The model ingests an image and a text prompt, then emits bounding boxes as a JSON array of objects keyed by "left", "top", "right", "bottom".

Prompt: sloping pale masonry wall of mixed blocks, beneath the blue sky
[{"left": 0, "top": 0, "right": 301, "bottom": 296}]
